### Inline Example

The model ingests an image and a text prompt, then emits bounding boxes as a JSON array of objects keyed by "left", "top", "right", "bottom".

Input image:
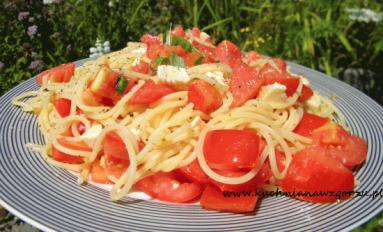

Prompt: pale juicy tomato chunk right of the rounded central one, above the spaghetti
[{"left": 229, "top": 64, "right": 263, "bottom": 107}]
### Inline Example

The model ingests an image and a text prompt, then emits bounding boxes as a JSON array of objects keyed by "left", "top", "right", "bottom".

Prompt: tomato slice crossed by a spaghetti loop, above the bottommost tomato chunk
[{"left": 211, "top": 163, "right": 272, "bottom": 192}]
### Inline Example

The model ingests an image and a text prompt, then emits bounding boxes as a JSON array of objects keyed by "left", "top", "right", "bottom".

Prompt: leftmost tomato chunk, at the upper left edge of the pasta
[{"left": 36, "top": 63, "right": 76, "bottom": 85}]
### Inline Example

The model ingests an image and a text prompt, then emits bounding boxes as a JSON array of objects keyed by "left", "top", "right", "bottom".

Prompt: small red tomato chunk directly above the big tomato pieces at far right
[{"left": 294, "top": 112, "right": 329, "bottom": 137}]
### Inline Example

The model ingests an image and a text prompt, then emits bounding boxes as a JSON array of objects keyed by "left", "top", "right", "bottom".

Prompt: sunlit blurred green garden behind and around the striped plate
[{"left": 0, "top": 0, "right": 383, "bottom": 230}]
